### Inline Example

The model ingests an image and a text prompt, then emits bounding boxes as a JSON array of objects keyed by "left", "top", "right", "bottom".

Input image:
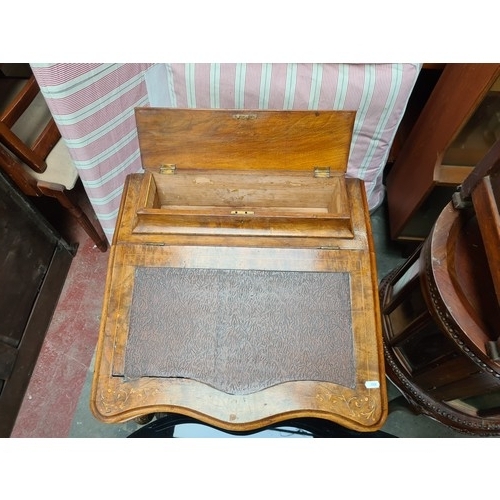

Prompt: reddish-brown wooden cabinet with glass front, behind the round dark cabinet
[{"left": 386, "top": 64, "right": 500, "bottom": 240}]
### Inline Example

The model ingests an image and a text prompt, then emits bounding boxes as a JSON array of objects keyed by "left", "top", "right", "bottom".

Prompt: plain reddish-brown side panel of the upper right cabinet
[{"left": 386, "top": 64, "right": 500, "bottom": 239}]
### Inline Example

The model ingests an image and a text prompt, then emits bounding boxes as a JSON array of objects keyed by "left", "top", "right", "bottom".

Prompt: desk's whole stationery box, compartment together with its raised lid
[{"left": 133, "top": 108, "right": 355, "bottom": 238}]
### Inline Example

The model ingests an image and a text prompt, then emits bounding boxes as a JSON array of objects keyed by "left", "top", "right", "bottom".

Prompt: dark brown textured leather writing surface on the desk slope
[{"left": 125, "top": 267, "right": 356, "bottom": 394}]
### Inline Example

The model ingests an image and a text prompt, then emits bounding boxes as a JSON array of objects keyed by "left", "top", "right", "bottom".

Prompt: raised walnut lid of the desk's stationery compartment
[{"left": 135, "top": 108, "right": 355, "bottom": 173}]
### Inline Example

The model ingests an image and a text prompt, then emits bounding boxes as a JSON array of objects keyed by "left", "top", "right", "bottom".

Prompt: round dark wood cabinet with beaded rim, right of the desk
[{"left": 380, "top": 140, "right": 500, "bottom": 435}]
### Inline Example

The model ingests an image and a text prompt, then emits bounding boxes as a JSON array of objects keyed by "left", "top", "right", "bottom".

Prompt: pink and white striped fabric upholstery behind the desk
[{"left": 32, "top": 63, "right": 420, "bottom": 240}]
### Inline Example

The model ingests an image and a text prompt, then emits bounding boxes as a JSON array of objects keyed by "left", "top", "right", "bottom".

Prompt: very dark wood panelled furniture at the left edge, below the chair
[{"left": 0, "top": 171, "right": 76, "bottom": 437}]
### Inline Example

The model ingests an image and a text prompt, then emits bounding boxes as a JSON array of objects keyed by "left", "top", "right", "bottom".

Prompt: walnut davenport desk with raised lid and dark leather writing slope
[{"left": 91, "top": 108, "right": 387, "bottom": 432}]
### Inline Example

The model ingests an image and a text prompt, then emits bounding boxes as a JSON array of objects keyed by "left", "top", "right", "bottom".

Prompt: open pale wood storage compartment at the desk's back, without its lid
[{"left": 134, "top": 169, "right": 354, "bottom": 238}]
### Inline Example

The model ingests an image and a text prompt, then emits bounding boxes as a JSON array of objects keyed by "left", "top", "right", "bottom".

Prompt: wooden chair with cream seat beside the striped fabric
[{"left": 0, "top": 66, "right": 108, "bottom": 252}]
